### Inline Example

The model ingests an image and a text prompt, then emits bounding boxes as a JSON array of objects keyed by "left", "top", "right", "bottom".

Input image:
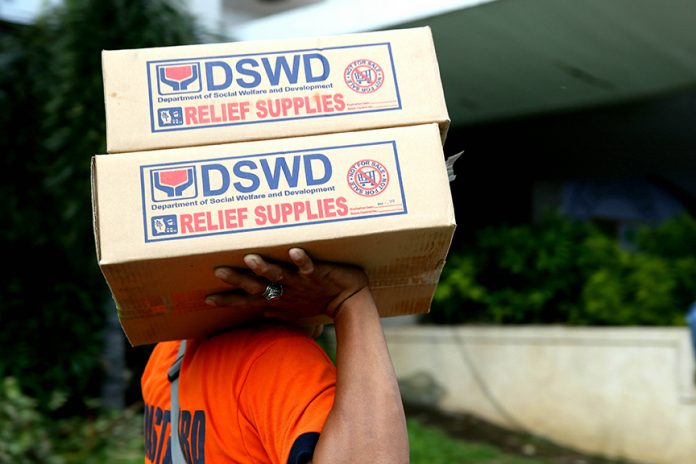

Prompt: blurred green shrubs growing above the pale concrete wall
[{"left": 424, "top": 215, "right": 696, "bottom": 325}]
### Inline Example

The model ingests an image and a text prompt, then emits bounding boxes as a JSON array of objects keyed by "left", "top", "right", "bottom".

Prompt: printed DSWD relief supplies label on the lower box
[{"left": 140, "top": 140, "right": 408, "bottom": 242}]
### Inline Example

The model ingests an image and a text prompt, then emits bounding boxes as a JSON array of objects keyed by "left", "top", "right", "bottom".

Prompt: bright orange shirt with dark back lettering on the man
[{"left": 141, "top": 324, "right": 336, "bottom": 464}]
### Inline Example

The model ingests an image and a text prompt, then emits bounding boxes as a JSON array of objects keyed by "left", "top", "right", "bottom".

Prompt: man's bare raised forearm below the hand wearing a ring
[{"left": 313, "top": 289, "right": 409, "bottom": 464}]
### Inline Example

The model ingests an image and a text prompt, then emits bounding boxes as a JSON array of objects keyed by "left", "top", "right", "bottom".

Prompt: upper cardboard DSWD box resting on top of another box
[{"left": 102, "top": 27, "right": 449, "bottom": 153}]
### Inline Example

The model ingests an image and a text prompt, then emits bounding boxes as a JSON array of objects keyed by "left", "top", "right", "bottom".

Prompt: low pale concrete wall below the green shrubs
[{"left": 385, "top": 324, "right": 696, "bottom": 464}]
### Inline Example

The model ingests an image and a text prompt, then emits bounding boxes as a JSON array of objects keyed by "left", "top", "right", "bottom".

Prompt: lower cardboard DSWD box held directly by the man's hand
[{"left": 92, "top": 124, "right": 455, "bottom": 345}]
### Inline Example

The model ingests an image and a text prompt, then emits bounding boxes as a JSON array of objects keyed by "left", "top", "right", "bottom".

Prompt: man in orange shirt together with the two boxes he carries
[{"left": 92, "top": 28, "right": 455, "bottom": 463}]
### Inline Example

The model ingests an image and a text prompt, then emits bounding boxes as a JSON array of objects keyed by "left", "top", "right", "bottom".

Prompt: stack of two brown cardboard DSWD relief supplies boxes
[{"left": 92, "top": 28, "right": 455, "bottom": 345}]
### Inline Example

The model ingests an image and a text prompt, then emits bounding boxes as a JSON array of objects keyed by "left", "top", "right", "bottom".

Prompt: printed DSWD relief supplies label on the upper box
[{"left": 147, "top": 43, "right": 401, "bottom": 132}]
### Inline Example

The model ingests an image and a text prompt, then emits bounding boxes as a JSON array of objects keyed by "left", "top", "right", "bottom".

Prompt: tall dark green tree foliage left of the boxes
[{"left": 0, "top": 0, "right": 198, "bottom": 414}]
